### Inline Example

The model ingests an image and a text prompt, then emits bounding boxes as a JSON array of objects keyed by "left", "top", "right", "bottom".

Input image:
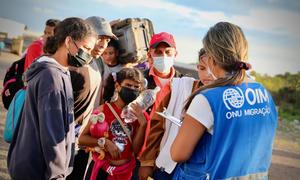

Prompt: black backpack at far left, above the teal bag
[{"left": 1, "top": 56, "right": 26, "bottom": 109}]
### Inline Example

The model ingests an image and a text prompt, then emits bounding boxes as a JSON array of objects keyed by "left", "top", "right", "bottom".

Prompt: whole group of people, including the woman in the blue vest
[{"left": 7, "top": 16, "right": 277, "bottom": 180}]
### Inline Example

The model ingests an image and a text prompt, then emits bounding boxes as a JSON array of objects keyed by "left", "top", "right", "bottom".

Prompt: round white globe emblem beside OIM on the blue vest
[{"left": 223, "top": 87, "right": 245, "bottom": 110}]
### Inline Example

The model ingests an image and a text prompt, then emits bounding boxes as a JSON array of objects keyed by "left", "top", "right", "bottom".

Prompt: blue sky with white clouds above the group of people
[{"left": 0, "top": 0, "right": 300, "bottom": 75}]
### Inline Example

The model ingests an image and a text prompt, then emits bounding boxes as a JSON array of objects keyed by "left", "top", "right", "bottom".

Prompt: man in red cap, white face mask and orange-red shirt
[{"left": 135, "top": 32, "right": 182, "bottom": 179}]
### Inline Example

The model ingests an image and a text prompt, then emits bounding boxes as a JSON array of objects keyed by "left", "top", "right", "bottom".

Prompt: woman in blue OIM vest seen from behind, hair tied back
[{"left": 171, "top": 22, "right": 277, "bottom": 180}]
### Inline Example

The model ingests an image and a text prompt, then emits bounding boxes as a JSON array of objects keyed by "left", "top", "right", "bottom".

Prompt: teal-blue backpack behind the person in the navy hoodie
[{"left": 3, "top": 88, "right": 26, "bottom": 143}]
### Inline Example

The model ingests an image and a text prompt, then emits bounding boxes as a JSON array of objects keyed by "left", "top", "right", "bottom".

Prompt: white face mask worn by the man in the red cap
[{"left": 153, "top": 56, "right": 174, "bottom": 73}]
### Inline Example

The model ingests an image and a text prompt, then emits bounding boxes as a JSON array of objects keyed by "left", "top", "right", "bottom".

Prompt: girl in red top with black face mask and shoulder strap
[{"left": 79, "top": 68, "right": 148, "bottom": 180}]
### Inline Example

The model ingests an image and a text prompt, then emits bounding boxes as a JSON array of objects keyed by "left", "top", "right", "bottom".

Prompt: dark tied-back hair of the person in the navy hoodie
[{"left": 43, "top": 17, "right": 96, "bottom": 54}]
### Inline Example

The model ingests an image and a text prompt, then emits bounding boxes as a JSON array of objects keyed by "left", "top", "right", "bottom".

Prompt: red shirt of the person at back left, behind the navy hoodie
[{"left": 24, "top": 38, "right": 44, "bottom": 71}]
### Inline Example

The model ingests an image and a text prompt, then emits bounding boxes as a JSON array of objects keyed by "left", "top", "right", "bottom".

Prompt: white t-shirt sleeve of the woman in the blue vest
[{"left": 186, "top": 94, "right": 214, "bottom": 134}]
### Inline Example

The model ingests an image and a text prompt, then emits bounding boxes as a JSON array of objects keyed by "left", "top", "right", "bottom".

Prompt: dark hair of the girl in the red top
[{"left": 103, "top": 68, "right": 145, "bottom": 102}]
